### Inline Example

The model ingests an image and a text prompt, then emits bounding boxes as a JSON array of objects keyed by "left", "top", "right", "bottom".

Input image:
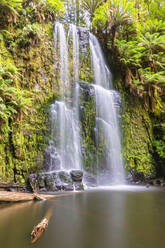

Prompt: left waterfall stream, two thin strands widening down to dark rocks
[{"left": 45, "top": 22, "right": 81, "bottom": 171}]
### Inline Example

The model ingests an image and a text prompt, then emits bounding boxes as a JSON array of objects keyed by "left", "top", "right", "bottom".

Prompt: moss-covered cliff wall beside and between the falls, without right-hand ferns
[{"left": 0, "top": 0, "right": 165, "bottom": 183}]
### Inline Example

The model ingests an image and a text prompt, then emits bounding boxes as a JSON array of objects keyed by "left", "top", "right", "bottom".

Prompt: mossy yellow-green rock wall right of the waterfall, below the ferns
[{"left": 121, "top": 87, "right": 155, "bottom": 176}]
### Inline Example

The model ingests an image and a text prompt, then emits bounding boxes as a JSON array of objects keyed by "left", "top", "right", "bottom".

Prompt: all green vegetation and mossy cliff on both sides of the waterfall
[{"left": 0, "top": 0, "right": 165, "bottom": 183}]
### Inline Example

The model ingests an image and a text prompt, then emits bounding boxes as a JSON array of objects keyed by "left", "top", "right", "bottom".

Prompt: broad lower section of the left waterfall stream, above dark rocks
[{"left": 51, "top": 101, "right": 81, "bottom": 170}]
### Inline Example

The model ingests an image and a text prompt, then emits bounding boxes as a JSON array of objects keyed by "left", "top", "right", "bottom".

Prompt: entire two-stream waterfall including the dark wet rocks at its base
[{"left": 29, "top": 22, "right": 125, "bottom": 191}]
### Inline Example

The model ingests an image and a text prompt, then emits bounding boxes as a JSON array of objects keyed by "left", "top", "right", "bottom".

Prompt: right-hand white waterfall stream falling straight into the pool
[{"left": 89, "top": 34, "right": 124, "bottom": 185}]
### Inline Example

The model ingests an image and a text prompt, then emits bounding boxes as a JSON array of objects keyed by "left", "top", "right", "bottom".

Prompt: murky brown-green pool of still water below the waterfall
[{"left": 0, "top": 187, "right": 165, "bottom": 248}]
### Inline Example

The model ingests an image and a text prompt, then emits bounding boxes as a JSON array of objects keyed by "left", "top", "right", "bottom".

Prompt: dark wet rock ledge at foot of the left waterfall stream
[{"left": 28, "top": 170, "right": 84, "bottom": 192}]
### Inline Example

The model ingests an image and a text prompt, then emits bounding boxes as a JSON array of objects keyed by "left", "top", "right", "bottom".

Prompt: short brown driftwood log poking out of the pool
[{"left": 31, "top": 205, "right": 53, "bottom": 243}]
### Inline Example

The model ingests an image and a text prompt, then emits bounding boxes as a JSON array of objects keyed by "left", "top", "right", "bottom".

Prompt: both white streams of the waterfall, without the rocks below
[{"left": 43, "top": 22, "right": 124, "bottom": 189}]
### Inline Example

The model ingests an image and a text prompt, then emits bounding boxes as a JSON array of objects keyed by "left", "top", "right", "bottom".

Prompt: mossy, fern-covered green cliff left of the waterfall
[{"left": 0, "top": 0, "right": 64, "bottom": 183}]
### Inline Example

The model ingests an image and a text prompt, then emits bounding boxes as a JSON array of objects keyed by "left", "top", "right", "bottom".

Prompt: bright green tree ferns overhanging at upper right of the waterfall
[{"left": 92, "top": 0, "right": 165, "bottom": 114}]
